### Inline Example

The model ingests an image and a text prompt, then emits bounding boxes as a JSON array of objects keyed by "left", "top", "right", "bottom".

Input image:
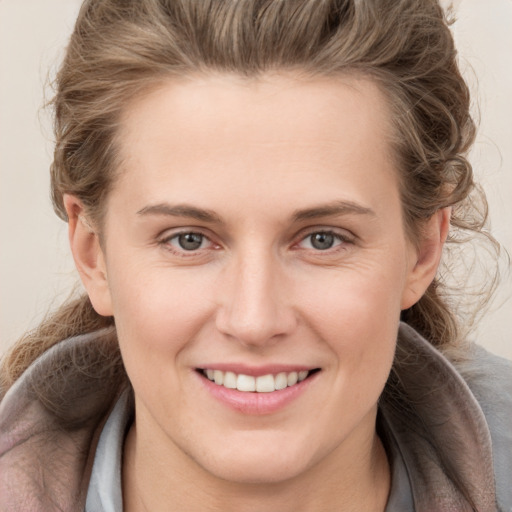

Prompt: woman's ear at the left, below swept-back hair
[{"left": 64, "top": 194, "right": 113, "bottom": 316}]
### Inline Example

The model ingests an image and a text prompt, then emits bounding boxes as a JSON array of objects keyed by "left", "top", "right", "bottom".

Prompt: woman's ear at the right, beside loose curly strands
[{"left": 402, "top": 208, "right": 451, "bottom": 309}]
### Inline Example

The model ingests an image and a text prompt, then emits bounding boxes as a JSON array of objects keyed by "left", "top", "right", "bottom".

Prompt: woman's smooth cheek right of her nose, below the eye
[{"left": 296, "top": 265, "right": 404, "bottom": 384}]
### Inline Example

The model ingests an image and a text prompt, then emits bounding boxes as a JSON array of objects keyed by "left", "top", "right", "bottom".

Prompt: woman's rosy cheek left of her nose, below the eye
[{"left": 105, "top": 264, "right": 215, "bottom": 386}]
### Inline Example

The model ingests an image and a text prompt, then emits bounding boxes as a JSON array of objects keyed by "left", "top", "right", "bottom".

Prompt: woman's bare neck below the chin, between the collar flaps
[{"left": 123, "top": 418, "right": 390, "bottom": 512}]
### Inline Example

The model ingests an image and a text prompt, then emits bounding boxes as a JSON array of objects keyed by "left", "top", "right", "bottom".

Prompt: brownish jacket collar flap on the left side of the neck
[{"left": 0, "top": 328, "right": 127, "bottom": 512}]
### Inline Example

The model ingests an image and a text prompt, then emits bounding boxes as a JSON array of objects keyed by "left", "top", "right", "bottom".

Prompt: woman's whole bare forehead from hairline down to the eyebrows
[{"left": 112, "top": 74, "right": 397, "bottom": 221}]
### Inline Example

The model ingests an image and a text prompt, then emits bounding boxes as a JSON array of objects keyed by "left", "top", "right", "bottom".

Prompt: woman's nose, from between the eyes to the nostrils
[{"left": 216, "top": 249, "right": 297, "bottom": 347}]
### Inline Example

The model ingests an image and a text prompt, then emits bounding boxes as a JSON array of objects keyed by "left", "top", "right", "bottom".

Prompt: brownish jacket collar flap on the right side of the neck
[{"left": 379, "top": 323, "right": 496, "bottom": 512}]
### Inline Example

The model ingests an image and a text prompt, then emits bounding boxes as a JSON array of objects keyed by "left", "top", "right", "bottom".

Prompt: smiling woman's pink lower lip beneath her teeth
[{"left": 196, "top": 372, "right": 320, "bottom": 415}]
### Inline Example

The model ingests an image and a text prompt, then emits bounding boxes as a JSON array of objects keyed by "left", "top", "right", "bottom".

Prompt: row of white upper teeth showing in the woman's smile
[{"left": 203, "top": 369, "right": 309, "bottom": 393}]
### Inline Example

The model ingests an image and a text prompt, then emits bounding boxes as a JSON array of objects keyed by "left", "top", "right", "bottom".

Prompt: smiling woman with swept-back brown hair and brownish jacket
[{"left": 0, "top": 0, "right": 512, "bottom": 512}]
